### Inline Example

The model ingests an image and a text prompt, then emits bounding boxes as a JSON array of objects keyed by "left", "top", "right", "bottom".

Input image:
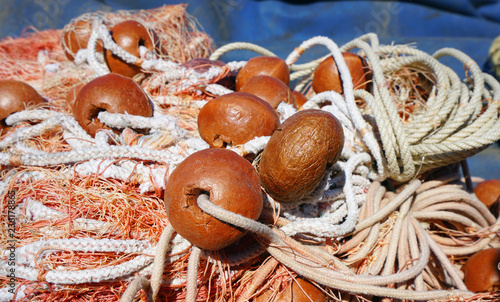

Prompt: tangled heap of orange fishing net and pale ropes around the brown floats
[{"left": 0, "top": 6, "right": 500, "bottom": 301}]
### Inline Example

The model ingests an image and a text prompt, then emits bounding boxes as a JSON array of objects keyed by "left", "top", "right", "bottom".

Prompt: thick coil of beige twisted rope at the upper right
[{"left": 291, "top": 34, "right": 500, "bottom": 183}]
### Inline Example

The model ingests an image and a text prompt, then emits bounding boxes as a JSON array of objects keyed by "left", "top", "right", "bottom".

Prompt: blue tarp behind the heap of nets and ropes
[{"left": 0, "top": 0, "right": 500, "bottom": 178}]
